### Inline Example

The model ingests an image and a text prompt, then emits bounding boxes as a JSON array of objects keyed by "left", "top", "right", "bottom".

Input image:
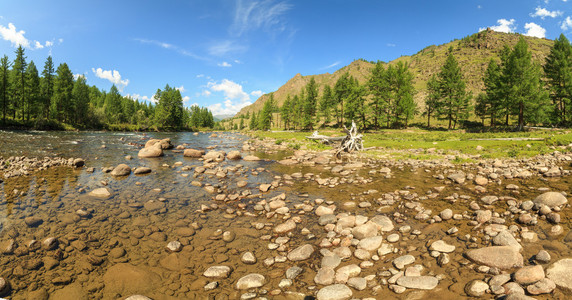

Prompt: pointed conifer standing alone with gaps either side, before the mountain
[{"left": 437, "top": 49, "right": 471, "bottom": 129}]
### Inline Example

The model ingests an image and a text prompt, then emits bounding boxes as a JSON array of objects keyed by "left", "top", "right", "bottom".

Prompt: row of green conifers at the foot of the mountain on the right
[{"left": 242, "top": 34, "right": 572, "bottom": 130}]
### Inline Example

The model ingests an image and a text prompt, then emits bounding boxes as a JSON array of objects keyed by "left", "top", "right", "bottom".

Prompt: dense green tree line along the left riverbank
[{"left": 0, "top": 46, "right": 215, "bottom": 130}]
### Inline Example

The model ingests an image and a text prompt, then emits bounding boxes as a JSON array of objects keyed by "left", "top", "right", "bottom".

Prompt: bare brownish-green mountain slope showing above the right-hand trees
[{"left": 236, "top": 29, "right": 554, "bottom": 116}]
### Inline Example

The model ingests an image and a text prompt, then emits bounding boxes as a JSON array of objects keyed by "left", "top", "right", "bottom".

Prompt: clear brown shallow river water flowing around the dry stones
[{"left": 0, "top": 132, "right": 572, "bottom": 299}]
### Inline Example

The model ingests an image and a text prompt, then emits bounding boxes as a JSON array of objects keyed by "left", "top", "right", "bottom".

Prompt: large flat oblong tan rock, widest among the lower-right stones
[{"left": 466, "top": 246, "right": 524, "bottom": 270}]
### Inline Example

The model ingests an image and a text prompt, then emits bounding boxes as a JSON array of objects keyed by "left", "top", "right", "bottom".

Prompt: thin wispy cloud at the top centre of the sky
[{"left": 231, "top": 0, "right": 292, "bottom": 36}]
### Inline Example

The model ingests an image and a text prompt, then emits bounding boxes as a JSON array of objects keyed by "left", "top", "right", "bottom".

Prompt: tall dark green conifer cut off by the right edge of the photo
[{"left": 544, "top": 34, "right": 572, "bottom": 123}]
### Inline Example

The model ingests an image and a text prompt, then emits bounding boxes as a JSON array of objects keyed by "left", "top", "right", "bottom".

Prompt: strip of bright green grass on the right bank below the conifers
[{"left": 253, "top": 128, "right": 572, "bottom": 159}]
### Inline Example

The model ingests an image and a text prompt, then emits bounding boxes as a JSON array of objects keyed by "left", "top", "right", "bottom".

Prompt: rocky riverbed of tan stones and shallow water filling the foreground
[{"left": 0, "top": 134, "right": 572, "bottom": 299}]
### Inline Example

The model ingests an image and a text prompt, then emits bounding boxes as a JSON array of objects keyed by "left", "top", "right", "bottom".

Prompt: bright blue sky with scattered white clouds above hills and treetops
[{"left": 0, "top": 0, "right": 572, "bottom": 115}]
